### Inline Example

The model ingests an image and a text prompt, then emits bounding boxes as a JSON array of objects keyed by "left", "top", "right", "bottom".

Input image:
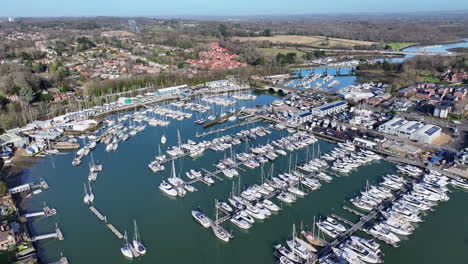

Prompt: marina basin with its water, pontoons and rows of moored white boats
[{"left": 17, "top": 82, "right": 465, "bottom": 263}]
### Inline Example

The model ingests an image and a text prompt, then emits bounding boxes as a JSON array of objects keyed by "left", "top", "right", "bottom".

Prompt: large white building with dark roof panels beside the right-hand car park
[{"left": 378, "top": 117, "right": 442, "bottom": 143}]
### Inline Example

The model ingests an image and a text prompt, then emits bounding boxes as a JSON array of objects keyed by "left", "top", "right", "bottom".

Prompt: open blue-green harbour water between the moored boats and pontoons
[{"left": 23, "top": 92, "right": 468, "bottom": 264}]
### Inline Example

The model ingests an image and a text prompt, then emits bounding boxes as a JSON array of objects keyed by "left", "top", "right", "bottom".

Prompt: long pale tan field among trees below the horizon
[{"left": 234, "top": 35, "right": 374, "bottom": 49}]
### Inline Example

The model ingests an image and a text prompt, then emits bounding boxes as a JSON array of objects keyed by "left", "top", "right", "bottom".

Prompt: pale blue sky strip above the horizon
[{"left": 0, "top": 0, "right": 468, "bottom": 17}]
